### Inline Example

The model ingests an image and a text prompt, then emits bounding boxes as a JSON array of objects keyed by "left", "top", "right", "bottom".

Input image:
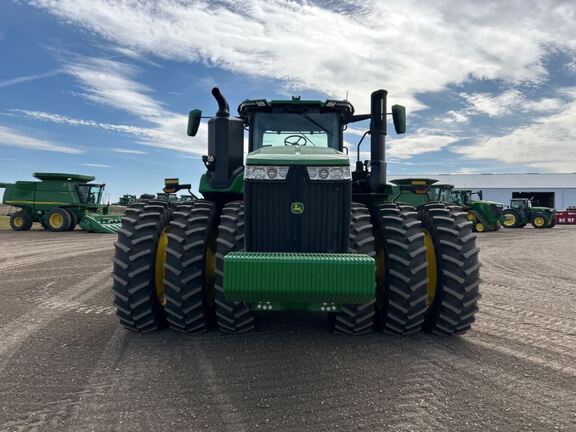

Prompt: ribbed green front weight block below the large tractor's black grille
[{"left": 224, "top": 252, "right": 375, "bottom": 311}]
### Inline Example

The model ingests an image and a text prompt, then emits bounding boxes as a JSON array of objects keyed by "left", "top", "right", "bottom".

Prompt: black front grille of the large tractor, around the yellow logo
[{"left": 244, "top": 166, "right": 352, "bottom": 253}]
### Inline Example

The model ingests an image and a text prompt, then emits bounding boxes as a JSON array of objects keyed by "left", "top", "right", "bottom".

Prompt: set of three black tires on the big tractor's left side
[{"left": 112, "top": 200, "right": 254, "bottom": 333}]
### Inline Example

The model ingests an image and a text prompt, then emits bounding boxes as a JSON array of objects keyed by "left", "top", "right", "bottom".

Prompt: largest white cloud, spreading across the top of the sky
[{"left": 30, "top": 0, "right": 576, "bottom": 111}]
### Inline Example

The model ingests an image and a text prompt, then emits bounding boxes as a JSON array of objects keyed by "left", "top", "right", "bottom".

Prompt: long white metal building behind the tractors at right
[{"left": 388, "top": 173, "right": 576, "bottom": 210}]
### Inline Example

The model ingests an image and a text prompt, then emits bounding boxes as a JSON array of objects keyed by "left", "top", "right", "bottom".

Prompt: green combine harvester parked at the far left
[{"left": 0, "top": 173, "right": 121, "bottom": 233}]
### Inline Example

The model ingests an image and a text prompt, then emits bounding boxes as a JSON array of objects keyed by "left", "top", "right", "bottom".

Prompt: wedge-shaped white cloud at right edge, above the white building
[{"left": 453, "top": 89, "right": 576, "bottom": 172}]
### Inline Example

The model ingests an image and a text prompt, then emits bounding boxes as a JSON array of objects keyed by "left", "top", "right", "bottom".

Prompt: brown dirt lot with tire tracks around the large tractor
[{"left": 0, "top": 226, "right": 576, "bottom": 432}]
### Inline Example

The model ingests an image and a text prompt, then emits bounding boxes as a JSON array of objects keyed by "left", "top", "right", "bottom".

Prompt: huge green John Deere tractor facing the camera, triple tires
[{"left": 113, "top": 88, "right": 480, "bottom": 335}]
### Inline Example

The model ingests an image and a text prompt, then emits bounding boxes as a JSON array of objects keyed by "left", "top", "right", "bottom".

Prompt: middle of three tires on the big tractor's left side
[{"left": 165, "top": 200, "right": 217, "bottom": 333}]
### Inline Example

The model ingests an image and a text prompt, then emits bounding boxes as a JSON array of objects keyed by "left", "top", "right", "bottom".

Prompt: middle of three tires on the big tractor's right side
[{"left": 372, "top": 203, "right": 428, "bottom": 335}]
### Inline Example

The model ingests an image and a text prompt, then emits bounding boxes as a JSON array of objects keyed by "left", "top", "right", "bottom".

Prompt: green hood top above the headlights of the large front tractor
[{"left": 246, "top": 146, "right": 350, "bottom": 166}]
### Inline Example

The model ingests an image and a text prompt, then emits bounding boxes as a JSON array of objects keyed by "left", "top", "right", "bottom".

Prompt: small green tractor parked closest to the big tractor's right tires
[{"left": 452, "top": 189, "right": 504, "bottom": 232}]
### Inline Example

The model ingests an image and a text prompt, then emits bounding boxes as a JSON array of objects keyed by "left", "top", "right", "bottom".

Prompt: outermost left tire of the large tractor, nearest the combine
[{"left": 112, "top": 201, "right": 171, "bottom": 333}]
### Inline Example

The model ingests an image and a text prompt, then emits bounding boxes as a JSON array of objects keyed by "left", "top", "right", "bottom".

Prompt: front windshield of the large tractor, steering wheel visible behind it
[{"left": 252, "top": 112, "right": 340, "bottom": 150}]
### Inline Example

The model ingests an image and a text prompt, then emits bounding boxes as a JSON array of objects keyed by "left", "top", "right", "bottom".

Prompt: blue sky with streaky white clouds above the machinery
[{"left": 0, "top": 0, "right": 576, "bottom": 201}]
